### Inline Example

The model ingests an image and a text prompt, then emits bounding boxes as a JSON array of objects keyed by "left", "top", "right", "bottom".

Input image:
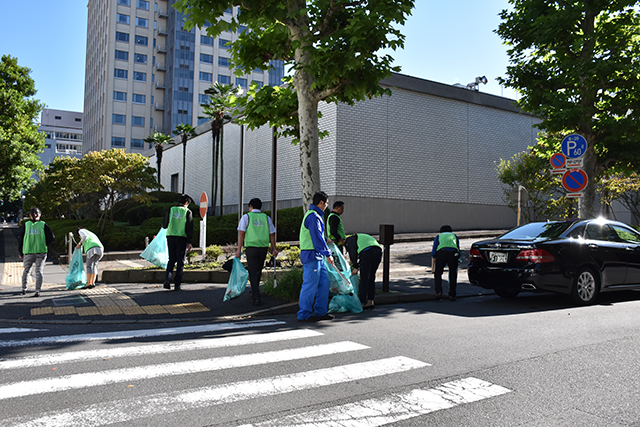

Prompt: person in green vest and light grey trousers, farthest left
[{"left": 18, "top": 207, "right": 55, "bottom": 297}]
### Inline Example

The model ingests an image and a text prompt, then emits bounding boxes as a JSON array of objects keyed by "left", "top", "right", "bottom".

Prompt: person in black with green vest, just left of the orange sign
[{"left": 162, "top": 194, "right": 193, "bottom": 291}]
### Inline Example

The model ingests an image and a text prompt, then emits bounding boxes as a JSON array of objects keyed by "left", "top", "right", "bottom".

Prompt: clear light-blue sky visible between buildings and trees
[{"left": 0, "top": 0, "right": 516, "bottom": 111}]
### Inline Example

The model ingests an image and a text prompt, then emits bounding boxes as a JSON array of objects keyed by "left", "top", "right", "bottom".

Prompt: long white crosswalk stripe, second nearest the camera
[{"left": 3, "top": 356, "right": 428, "bottom": 427}]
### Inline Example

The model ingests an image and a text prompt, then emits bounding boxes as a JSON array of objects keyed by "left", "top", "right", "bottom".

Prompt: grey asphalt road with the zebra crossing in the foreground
[{"left": 0, "top": 292, "right": 640, "bottom": 427}]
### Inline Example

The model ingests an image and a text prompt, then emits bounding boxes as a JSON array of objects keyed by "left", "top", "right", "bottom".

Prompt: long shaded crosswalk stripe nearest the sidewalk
[{"left": 0, "top": 319, "right": 286, "bottom": 347}]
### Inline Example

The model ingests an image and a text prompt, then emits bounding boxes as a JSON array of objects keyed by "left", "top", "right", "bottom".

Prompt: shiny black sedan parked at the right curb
[{"left": 467, "top": 218, "right": 640, "bottom": 305}]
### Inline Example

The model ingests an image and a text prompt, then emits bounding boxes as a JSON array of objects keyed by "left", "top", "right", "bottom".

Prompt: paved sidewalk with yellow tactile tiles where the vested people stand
[{"left": 0, "top": 224, "right": 500, "bottom": 324}]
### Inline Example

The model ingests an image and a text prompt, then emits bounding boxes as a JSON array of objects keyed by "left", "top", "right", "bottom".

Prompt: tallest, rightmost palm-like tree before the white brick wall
[{"left": 202, "top": 82, "right": 241, "bottom": 215}]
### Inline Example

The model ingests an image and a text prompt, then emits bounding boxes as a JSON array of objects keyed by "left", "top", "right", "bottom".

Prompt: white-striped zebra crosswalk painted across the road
[{"left": 0, "top": 319, "right": 510, "bottom": 427}]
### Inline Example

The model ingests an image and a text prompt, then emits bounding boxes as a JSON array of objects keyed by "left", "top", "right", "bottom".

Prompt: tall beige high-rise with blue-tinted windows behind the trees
[{"left": 83, "top": 0, "right": 284, "bottom": 152}]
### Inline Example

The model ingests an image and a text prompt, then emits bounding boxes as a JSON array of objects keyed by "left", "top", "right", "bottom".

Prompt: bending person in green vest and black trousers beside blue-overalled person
[{"left": 346, "top": 233, "right": 382, "bottom": 310}]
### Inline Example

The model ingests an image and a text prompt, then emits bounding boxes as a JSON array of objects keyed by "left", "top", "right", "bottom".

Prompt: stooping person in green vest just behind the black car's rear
[{"left": 431, "top": 225, "right": 460, "bottom": 301}]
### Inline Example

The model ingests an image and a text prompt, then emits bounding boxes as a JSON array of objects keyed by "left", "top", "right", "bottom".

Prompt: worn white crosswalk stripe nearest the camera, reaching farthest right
[{"left": 240, "top": 377, "right": 511, "bottom": 427}]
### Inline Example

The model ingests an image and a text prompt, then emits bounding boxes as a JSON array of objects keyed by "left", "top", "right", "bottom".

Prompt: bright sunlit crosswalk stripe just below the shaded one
[{"left": 0, "top": 329, "right": 322, "bottom": 370}]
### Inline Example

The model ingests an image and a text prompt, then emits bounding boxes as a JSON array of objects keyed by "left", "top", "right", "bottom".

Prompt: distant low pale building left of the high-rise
[{"left": 38, "top": 108, "right": 82, "bottom": 166}]
